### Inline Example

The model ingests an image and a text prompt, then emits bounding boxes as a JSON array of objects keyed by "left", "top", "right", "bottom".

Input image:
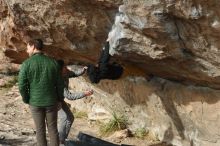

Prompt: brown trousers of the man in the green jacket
[{"left": 30, "top": 105, "right": 59, "bottom": 146}]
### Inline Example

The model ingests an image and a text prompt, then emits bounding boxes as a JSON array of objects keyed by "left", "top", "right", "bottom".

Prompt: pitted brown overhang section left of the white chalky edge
[{"left": 0, "top": 0, "right": 120, "bottom": 63}]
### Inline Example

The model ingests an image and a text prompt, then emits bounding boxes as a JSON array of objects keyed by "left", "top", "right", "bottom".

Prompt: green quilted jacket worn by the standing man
[{"left": 18, "top": 53, "right": 63, "bottom": 107}]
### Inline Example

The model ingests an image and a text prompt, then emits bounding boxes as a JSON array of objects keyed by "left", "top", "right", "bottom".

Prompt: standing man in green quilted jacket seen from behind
[{"left": 19, "top": 39, "right": 63, "bottom": 146}]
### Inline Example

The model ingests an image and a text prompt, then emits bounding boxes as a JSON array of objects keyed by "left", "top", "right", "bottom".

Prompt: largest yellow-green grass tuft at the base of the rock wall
[{"left": 99, "top": 112, "right": 128, "bottom": 136}]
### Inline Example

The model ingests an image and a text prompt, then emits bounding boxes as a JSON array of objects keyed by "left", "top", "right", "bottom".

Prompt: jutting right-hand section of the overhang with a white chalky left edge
[{"left": 110, "top": 0, "right": 220, "bottom": 88}]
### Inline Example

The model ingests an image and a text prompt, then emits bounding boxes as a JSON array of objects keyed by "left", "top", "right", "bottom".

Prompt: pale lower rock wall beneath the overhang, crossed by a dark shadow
[{"left": 68, "top": 74, "right": 220, "bottom": 146}]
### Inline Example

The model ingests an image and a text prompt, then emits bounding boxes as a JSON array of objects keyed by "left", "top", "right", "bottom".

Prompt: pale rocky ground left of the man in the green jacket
[{"left": 0, "top": 87, "right": 35, "bottom": 146}]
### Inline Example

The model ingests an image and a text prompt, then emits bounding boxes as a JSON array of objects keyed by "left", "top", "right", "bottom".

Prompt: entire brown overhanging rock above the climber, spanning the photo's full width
[{"left": 0, "top": 0, "right": 220, "bottom": 88}]
